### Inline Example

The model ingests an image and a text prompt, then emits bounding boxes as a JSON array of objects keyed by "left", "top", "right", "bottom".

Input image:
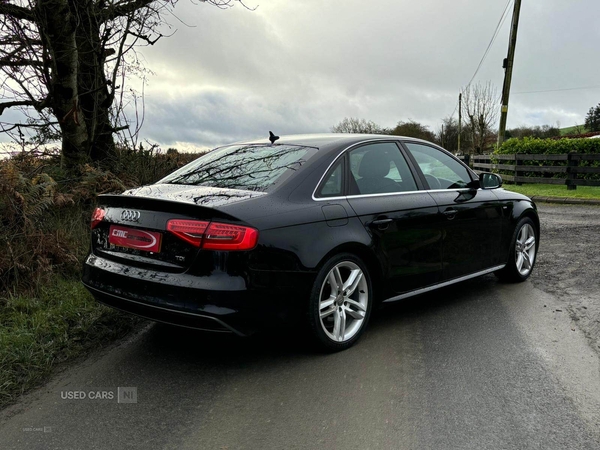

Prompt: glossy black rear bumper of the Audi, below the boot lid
[{"left": 82, "top": 254, "right": 314, "bottom": 335}]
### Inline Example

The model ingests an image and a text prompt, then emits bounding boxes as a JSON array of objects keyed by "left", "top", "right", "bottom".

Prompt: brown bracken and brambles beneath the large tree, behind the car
[{"left": 0, "top": 149, "right": 198, "bottom": 296}]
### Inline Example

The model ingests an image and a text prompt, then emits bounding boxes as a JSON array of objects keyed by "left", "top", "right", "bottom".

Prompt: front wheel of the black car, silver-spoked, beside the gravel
[{"left": 496, "top": 217, "right": 538, "bottom": 282}]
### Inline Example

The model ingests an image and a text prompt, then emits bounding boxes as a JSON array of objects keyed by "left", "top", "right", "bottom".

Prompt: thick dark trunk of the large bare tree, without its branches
[{"left": 39, "top": 0, "right": 114, "bottom": 170}]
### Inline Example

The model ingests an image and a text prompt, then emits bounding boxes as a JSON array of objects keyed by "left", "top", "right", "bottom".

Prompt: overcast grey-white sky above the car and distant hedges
[{"left": 5, "top": 0, "right": 600, "bottom": 150}]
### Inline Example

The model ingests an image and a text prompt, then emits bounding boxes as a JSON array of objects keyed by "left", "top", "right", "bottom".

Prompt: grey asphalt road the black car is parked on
[{"left": 0, "top": 270, "right": 600, "bottom": 450}]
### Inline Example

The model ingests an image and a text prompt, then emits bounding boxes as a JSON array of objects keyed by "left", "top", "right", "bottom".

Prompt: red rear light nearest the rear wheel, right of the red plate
[{"left": 167, "top": 219, "right": 258, "bottom": 250}]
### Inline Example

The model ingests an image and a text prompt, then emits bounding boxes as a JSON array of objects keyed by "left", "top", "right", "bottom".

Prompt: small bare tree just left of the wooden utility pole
[{"left": 462, "top": 81, "right": 500, "bottom": 154}]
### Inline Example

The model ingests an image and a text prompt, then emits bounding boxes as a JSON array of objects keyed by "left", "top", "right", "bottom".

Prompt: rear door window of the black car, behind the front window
[{"left": 349, "top": 142, "right": 417, "bottom": 194}]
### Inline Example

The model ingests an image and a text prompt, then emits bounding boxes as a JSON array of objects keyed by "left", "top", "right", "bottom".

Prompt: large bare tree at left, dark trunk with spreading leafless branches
[{"left": 0, "top": 0, "right": 250, "bottom": 168}]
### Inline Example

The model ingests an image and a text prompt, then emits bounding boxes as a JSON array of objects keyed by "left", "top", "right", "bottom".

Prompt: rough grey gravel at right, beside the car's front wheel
[{"left": 531, "top": 201, "right": 600, "bottom": 352}]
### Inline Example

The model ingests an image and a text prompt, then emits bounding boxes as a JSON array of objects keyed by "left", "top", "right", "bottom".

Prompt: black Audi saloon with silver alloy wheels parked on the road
[{"left": 83, "top": 134, "right": 540, "bottom": 351}]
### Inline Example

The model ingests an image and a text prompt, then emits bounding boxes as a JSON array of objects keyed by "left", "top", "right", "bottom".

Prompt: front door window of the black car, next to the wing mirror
[{"left": 405, "top": 143, "right": 471, "bottom": 189}]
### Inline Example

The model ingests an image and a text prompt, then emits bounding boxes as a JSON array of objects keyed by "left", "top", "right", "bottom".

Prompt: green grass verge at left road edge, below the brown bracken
[{"left": 0, "top": 276, "right": 140, "bottom": 407}]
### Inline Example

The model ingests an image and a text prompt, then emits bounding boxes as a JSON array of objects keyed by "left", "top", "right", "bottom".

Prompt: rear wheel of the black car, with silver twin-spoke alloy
[{"left": 308, "top": 253, "right": 373, "bottom": 352}]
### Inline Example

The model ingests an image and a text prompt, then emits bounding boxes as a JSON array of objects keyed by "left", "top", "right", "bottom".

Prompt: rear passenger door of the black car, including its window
[{"left": 346, "top": 142, "right": 442, "bottom": 297}]
